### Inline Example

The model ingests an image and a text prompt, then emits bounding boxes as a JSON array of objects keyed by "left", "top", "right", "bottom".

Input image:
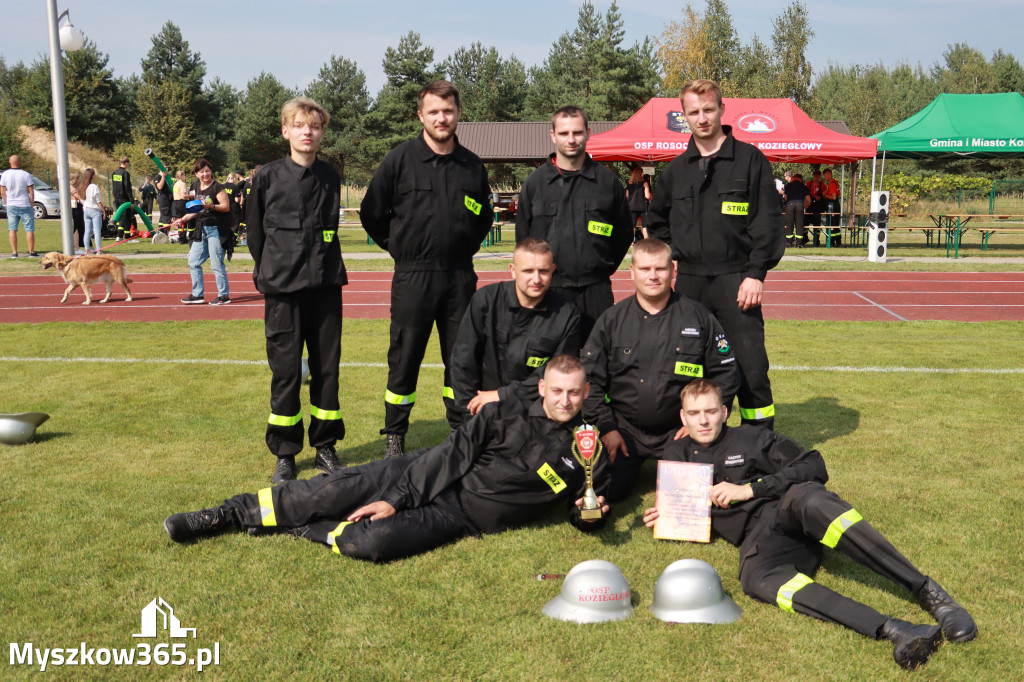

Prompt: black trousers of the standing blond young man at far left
[{"left": 263, "top": 285, "right": 345, "bottom": 457}]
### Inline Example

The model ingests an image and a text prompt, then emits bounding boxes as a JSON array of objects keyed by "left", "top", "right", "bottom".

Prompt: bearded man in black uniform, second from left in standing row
[{"left": 359, "top": 81, "right": 494, "bottom": 457}]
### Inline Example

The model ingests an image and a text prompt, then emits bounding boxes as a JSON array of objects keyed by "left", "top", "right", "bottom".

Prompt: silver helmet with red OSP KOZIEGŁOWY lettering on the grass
[{"left": 544, "top": 559, "right": 633, "bottom": 623}]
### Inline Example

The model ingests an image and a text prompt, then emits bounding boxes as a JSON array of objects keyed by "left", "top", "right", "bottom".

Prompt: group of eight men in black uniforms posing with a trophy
[{"left": 164, "top": 80, "right": 977, "bottom": 668}]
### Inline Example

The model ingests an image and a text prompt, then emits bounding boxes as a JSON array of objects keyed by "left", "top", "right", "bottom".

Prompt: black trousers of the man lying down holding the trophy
[{"left": 224, "top": 453, "right": 479, "bottom": 562}]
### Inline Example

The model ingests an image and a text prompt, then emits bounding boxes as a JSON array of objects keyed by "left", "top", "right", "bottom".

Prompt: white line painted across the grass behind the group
[{"left": 0, "top": 355, "right": 1024, "bottom": 374}]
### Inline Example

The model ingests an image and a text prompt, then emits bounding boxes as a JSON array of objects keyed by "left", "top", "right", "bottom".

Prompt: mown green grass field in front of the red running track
[{"left": 0, "top": 321, "right": 1024, "bottom": 680}]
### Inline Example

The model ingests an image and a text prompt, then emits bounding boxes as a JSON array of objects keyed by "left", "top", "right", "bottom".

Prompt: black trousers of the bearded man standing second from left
[{"left": 381, "top": 269, "right": 476, "bottom": 435}]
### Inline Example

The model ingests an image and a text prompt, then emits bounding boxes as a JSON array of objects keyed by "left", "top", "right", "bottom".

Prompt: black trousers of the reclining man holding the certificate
[{"left": 739, "top": 482, "right": 928, "bottom": 637}]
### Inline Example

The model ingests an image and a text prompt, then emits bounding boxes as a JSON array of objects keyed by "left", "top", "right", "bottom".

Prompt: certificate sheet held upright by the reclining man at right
[{"left": 654, "top": 460, "right": 714, "bottom": 543}]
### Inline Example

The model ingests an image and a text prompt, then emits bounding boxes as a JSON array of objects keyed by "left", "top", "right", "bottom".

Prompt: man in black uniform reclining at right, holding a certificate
[{"left": 644, "top": 381, "right": 978, "bottom": 668}]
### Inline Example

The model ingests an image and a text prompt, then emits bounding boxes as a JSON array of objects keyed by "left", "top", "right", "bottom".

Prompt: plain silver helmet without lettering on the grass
[{"left": 650, "top": 559, "right": 742, "bottom": 624}]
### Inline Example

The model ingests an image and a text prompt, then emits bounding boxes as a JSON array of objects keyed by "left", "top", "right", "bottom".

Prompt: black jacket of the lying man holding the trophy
[{"left": 384, "top": 398, "right": 606, "bottom": 532}]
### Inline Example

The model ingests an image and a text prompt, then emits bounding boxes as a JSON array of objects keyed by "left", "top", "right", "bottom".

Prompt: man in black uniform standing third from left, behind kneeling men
[{"left": 515, "top": 106, "right": 633, "bottom": 339}]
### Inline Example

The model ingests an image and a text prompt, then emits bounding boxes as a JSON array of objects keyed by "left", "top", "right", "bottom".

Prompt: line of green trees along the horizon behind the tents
[{"left": 0, "top": 0, "right": 1024, "bottom": 182}]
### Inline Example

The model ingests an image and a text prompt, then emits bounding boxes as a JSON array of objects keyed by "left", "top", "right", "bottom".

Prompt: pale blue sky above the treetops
[{"left": 0, "top": 0, "right": 1024, "bottom": 96}]
